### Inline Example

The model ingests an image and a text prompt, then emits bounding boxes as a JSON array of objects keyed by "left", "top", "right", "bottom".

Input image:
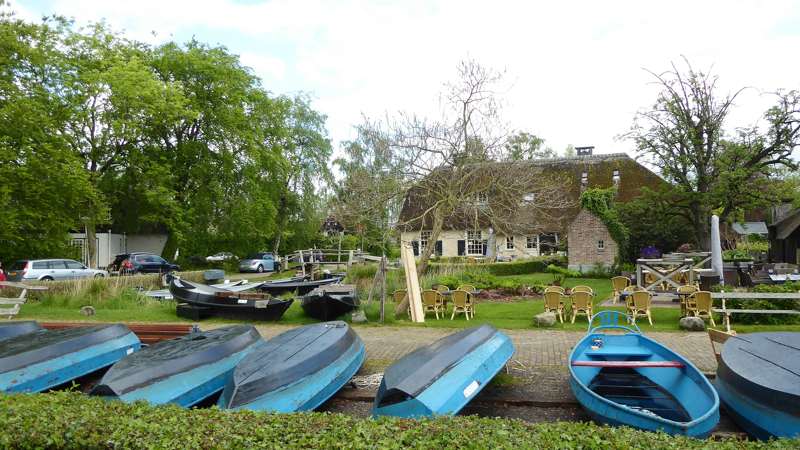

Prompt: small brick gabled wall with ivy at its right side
[{"left": 567, "top": 209, "right": 618, "bottom": 270}]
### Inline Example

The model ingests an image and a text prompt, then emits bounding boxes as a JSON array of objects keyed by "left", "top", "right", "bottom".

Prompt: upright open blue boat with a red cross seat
[{"left": 569, "top": 311, "right": 719, "bottom": 437}]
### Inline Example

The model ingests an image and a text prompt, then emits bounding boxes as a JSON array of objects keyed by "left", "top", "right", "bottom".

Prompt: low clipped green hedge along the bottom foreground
[{"left": 0, "top": 392, "right": 800, "bottom": 450}]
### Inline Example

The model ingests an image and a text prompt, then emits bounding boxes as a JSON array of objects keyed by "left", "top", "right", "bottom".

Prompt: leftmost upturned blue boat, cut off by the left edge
[{"left": 0, "top": 324, "right": 141, "bottom": 392}]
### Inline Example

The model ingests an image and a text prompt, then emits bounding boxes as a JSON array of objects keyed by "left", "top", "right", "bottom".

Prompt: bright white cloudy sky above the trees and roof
[{"left": 11, "top": 0, "right": 800, "bottom": 158}]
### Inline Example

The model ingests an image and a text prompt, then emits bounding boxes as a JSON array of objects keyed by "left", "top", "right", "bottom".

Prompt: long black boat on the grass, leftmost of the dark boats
[{"left": 169, "top": 278, "right": 294, "bottom": 320}]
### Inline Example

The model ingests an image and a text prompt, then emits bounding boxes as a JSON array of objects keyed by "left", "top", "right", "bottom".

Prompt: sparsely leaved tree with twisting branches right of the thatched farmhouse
[{"left": 626, "top": 61, "right": 800, "bottom": 249}]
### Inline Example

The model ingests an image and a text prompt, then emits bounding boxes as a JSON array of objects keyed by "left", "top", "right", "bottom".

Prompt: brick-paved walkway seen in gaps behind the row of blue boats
[{"left": 245, "top": 324, "right": 717, "bottom": 372}]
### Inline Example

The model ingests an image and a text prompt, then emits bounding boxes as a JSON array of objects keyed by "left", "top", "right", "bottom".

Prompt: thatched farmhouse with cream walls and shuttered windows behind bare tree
[{"left": 400, "top": 150, "right": 664, "bottom": 266}]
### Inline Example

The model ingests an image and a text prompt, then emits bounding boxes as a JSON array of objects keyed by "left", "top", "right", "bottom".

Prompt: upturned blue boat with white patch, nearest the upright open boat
[{"left": 372, "top": 325, "right": 514, "bottom": 417}]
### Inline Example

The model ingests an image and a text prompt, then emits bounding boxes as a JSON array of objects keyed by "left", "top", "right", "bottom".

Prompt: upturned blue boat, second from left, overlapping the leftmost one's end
[{"left": 91, "top": 325, "right": 261, "bottom": 407}]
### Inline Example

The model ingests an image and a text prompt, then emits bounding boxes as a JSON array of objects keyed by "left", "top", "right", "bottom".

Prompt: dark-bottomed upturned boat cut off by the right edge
[{"left": 714, "top": 332, "right": 800, "bottom": 439}]
